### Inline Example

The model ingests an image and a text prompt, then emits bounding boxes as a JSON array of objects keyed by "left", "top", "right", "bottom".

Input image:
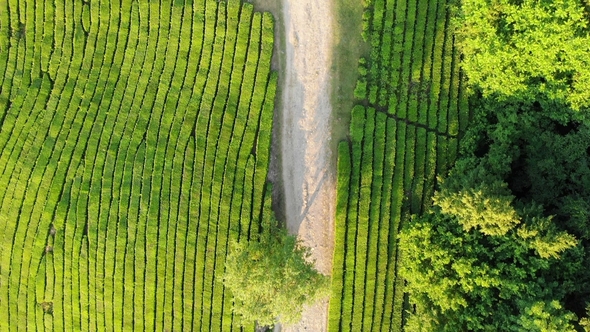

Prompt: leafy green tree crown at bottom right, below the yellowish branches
[{"left": 400, "top": 213, "right": 575, "bottom": 331}]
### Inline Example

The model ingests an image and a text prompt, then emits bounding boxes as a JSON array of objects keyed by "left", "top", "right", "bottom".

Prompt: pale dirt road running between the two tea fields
[{"left": 279, "top": 0, "right": 336, "bottom": 332}]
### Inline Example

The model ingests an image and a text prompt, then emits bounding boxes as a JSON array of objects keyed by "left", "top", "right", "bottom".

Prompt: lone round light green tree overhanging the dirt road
[{"left": 223, "top": 220, "right": 329, "bottom": 326}]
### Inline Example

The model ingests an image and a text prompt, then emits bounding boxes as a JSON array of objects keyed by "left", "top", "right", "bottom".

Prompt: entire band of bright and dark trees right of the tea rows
[{"left": 400, "top": 0, "right": 590, "bottom": 331}]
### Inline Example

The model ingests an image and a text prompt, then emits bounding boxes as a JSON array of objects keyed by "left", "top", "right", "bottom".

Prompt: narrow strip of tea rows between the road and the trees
[{"left": 329, "top": 0, "right": 468, "bottom": 331}]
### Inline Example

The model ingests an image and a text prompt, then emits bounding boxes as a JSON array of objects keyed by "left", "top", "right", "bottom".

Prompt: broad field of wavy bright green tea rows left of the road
[{"left": 0, "top": 0, "right": 277, "bottom": 331}]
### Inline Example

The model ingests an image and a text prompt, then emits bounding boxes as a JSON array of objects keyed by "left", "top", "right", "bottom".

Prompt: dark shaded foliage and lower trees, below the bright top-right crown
[{"left": 400, "top": 57, "right": 590, "bottom": 331}]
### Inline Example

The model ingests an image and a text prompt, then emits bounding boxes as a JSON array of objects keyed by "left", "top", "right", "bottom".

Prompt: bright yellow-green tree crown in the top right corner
[{"left": 456, "top": 0, "right": 590, "bottom": 109}]
